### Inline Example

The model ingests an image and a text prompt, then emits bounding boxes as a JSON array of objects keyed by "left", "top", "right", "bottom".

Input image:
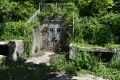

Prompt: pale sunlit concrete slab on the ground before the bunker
[{"left": 25, "top": 52, "right": 55, "bottom": 64}]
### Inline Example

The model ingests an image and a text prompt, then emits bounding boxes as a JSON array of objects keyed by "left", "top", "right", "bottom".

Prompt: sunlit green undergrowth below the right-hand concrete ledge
[{"left": 51, "top": 52, "right": 120, "bottom": 80}]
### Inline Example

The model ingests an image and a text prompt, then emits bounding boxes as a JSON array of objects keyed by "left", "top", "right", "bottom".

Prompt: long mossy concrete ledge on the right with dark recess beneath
[{"left": 69, "top": 43, "right": 120, "bottom": 61}]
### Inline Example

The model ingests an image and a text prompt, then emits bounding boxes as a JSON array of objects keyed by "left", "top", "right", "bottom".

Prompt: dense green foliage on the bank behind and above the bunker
[{"left": 0, "top": 0, "right": 120, "bottom": 46}]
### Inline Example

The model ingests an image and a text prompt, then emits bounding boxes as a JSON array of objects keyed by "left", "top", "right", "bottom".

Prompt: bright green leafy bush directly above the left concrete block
[{"left": 1, "top": 21, "right": 32, "bottom": 40}]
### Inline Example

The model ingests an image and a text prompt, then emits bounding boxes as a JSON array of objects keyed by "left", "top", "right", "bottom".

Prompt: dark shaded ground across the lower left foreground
[{"left": 0, "top": 57, "right": 77, "bottom": 80}]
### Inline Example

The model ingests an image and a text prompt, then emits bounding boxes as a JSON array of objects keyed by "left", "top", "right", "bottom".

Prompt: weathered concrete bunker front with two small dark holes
[{"left": 32, "top": 15, "right": 66, "bottom": 54}]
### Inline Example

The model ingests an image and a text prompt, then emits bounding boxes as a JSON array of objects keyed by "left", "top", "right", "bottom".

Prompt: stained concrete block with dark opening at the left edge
[{"left": 0, "top": 40, "right": 24, "bottom": 60}]
